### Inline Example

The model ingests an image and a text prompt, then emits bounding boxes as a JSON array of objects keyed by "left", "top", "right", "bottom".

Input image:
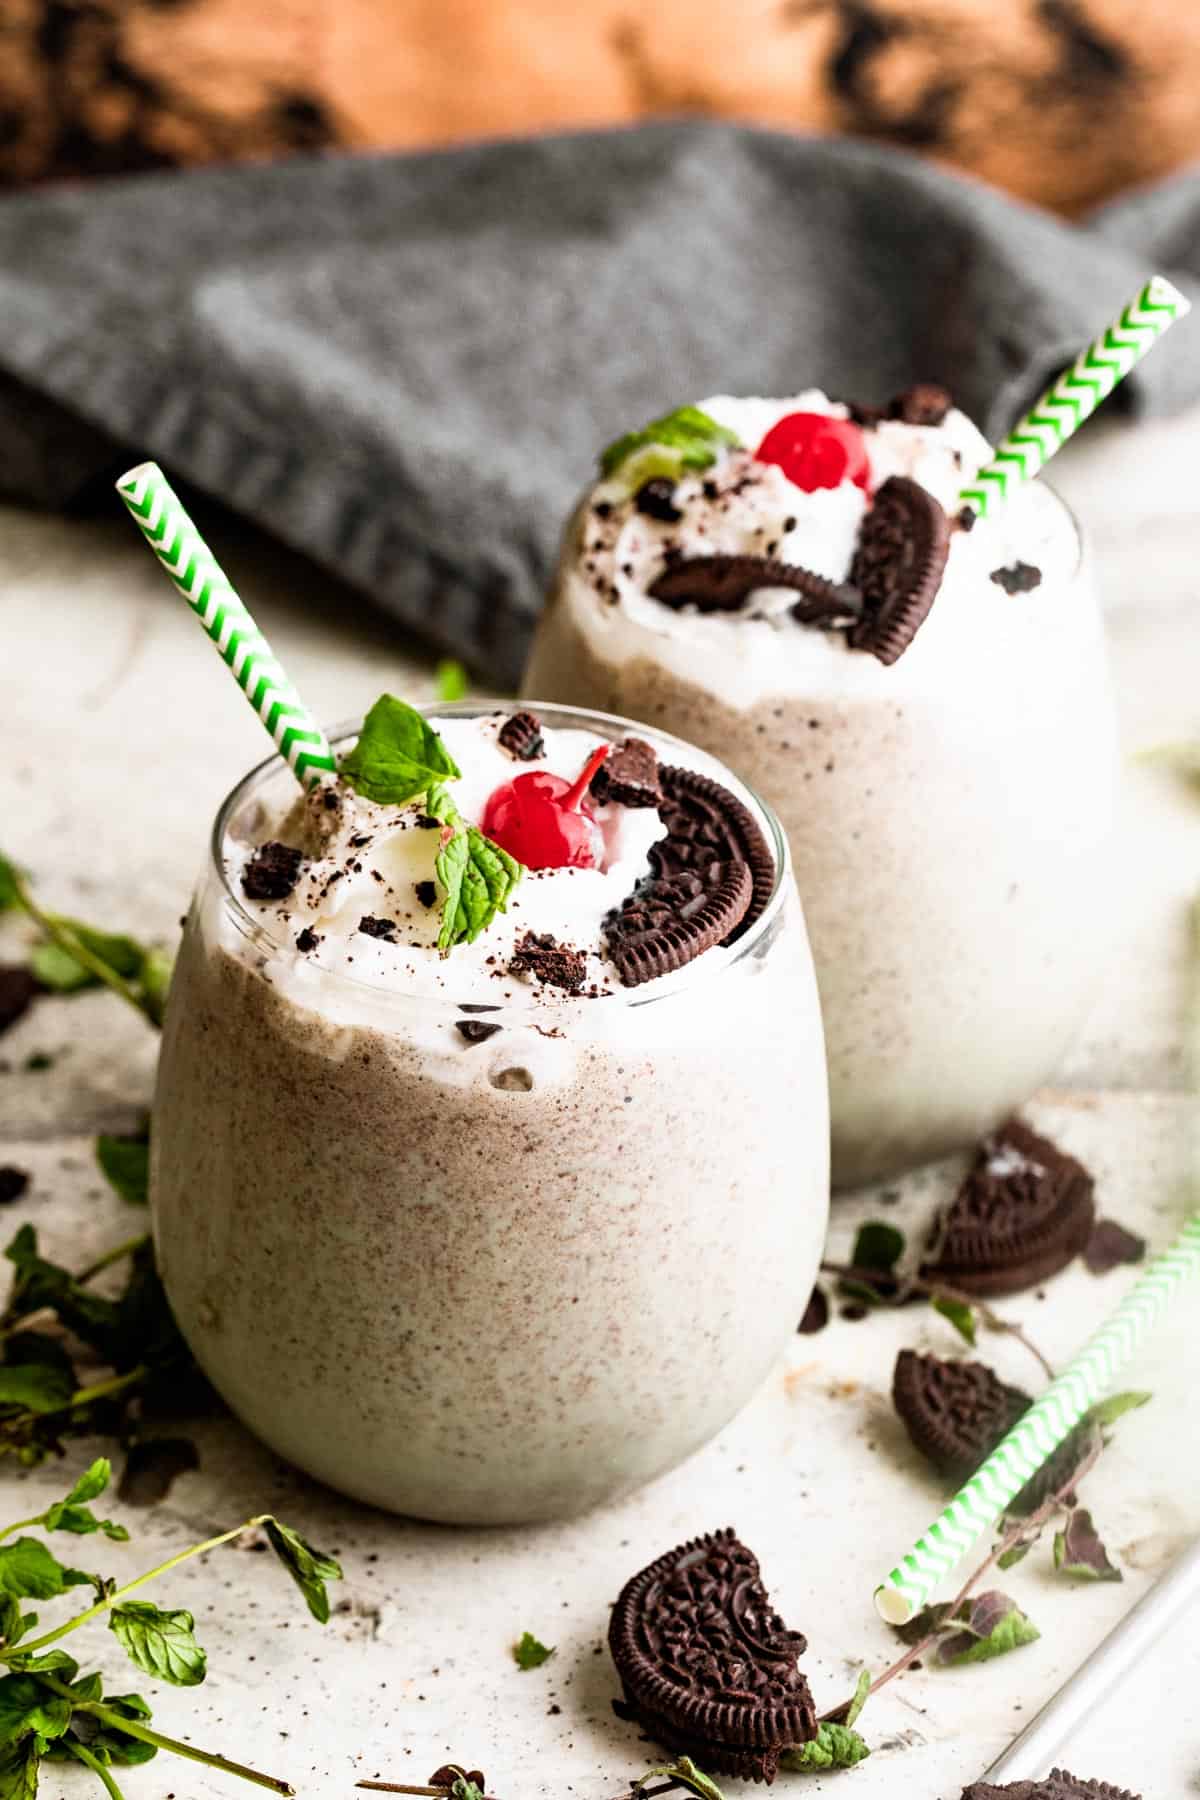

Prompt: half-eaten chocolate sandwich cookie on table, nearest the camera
[{"left": 608, "top": 1530, "right": 817, "bottom": 1782}]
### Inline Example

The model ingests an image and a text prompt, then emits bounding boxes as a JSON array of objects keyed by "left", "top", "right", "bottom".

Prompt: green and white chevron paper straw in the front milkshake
[{"left": 117, "top": 463, "right": 338, "bottom": 787}]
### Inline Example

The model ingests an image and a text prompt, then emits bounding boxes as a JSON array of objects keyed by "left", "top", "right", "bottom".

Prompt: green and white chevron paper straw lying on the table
[{"left": 874, "top": 1213, "right": 1200, "bottom": 1625}]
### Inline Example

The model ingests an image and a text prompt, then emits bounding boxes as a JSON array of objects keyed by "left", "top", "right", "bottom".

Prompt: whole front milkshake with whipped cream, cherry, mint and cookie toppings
[{"left": 151, "top": 697, "right": 829, "bottom": 1523}]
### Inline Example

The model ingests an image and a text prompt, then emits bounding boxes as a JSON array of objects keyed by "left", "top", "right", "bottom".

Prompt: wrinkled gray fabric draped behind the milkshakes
[{"left": 0, "top": 122, "right": 1200, "bottom": 682}]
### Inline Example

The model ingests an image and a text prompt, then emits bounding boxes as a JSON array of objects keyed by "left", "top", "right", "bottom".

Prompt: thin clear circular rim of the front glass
[{"left": 205, "top": 698, "right": 793, "bottom": 1024}]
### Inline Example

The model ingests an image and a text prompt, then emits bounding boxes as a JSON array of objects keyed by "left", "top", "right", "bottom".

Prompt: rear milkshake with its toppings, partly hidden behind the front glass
[{"left": 527, "top": 385, "right": 1115, "bottom": 1186}]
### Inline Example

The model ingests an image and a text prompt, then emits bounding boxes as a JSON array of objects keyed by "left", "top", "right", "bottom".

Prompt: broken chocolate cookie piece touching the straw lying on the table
[{"left": 892, "top": 1350, "right": 1033, "bottom": 1481}]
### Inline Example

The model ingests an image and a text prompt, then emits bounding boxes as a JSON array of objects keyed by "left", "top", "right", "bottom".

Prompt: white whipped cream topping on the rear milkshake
[{"left": 560, "top": 389, "right": 1078, "bottom": 707}]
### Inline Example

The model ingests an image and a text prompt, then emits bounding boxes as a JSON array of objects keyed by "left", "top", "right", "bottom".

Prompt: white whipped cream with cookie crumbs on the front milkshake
[{"left": 227, "top": 713, "right": 759, "bottom": 1006}]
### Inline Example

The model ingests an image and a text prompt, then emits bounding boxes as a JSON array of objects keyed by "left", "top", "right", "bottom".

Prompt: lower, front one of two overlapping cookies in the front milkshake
[{"left": 604, "top": 862, "right": 754, "bottom": 988}]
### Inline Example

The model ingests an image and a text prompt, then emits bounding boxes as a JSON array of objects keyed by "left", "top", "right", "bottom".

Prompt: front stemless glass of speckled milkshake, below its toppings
[{"left": 151, "top": 706, "right": 829, "bottom": 1523}]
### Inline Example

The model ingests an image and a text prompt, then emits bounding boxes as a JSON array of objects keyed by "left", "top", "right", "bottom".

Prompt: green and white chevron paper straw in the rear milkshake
[{"left": 959, "top": 275, "right": 1191, "bottom": 518}]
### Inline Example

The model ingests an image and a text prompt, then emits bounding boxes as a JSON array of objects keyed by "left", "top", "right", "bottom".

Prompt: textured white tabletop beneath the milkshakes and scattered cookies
[{"left": 0, "top": 414, "right": 1200, "bottom": 1800}]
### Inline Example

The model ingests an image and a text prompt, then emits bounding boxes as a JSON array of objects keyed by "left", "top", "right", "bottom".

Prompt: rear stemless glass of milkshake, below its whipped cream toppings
[{"left": 525, "top": 482, "right": 1117, "bottom": 1186}]
